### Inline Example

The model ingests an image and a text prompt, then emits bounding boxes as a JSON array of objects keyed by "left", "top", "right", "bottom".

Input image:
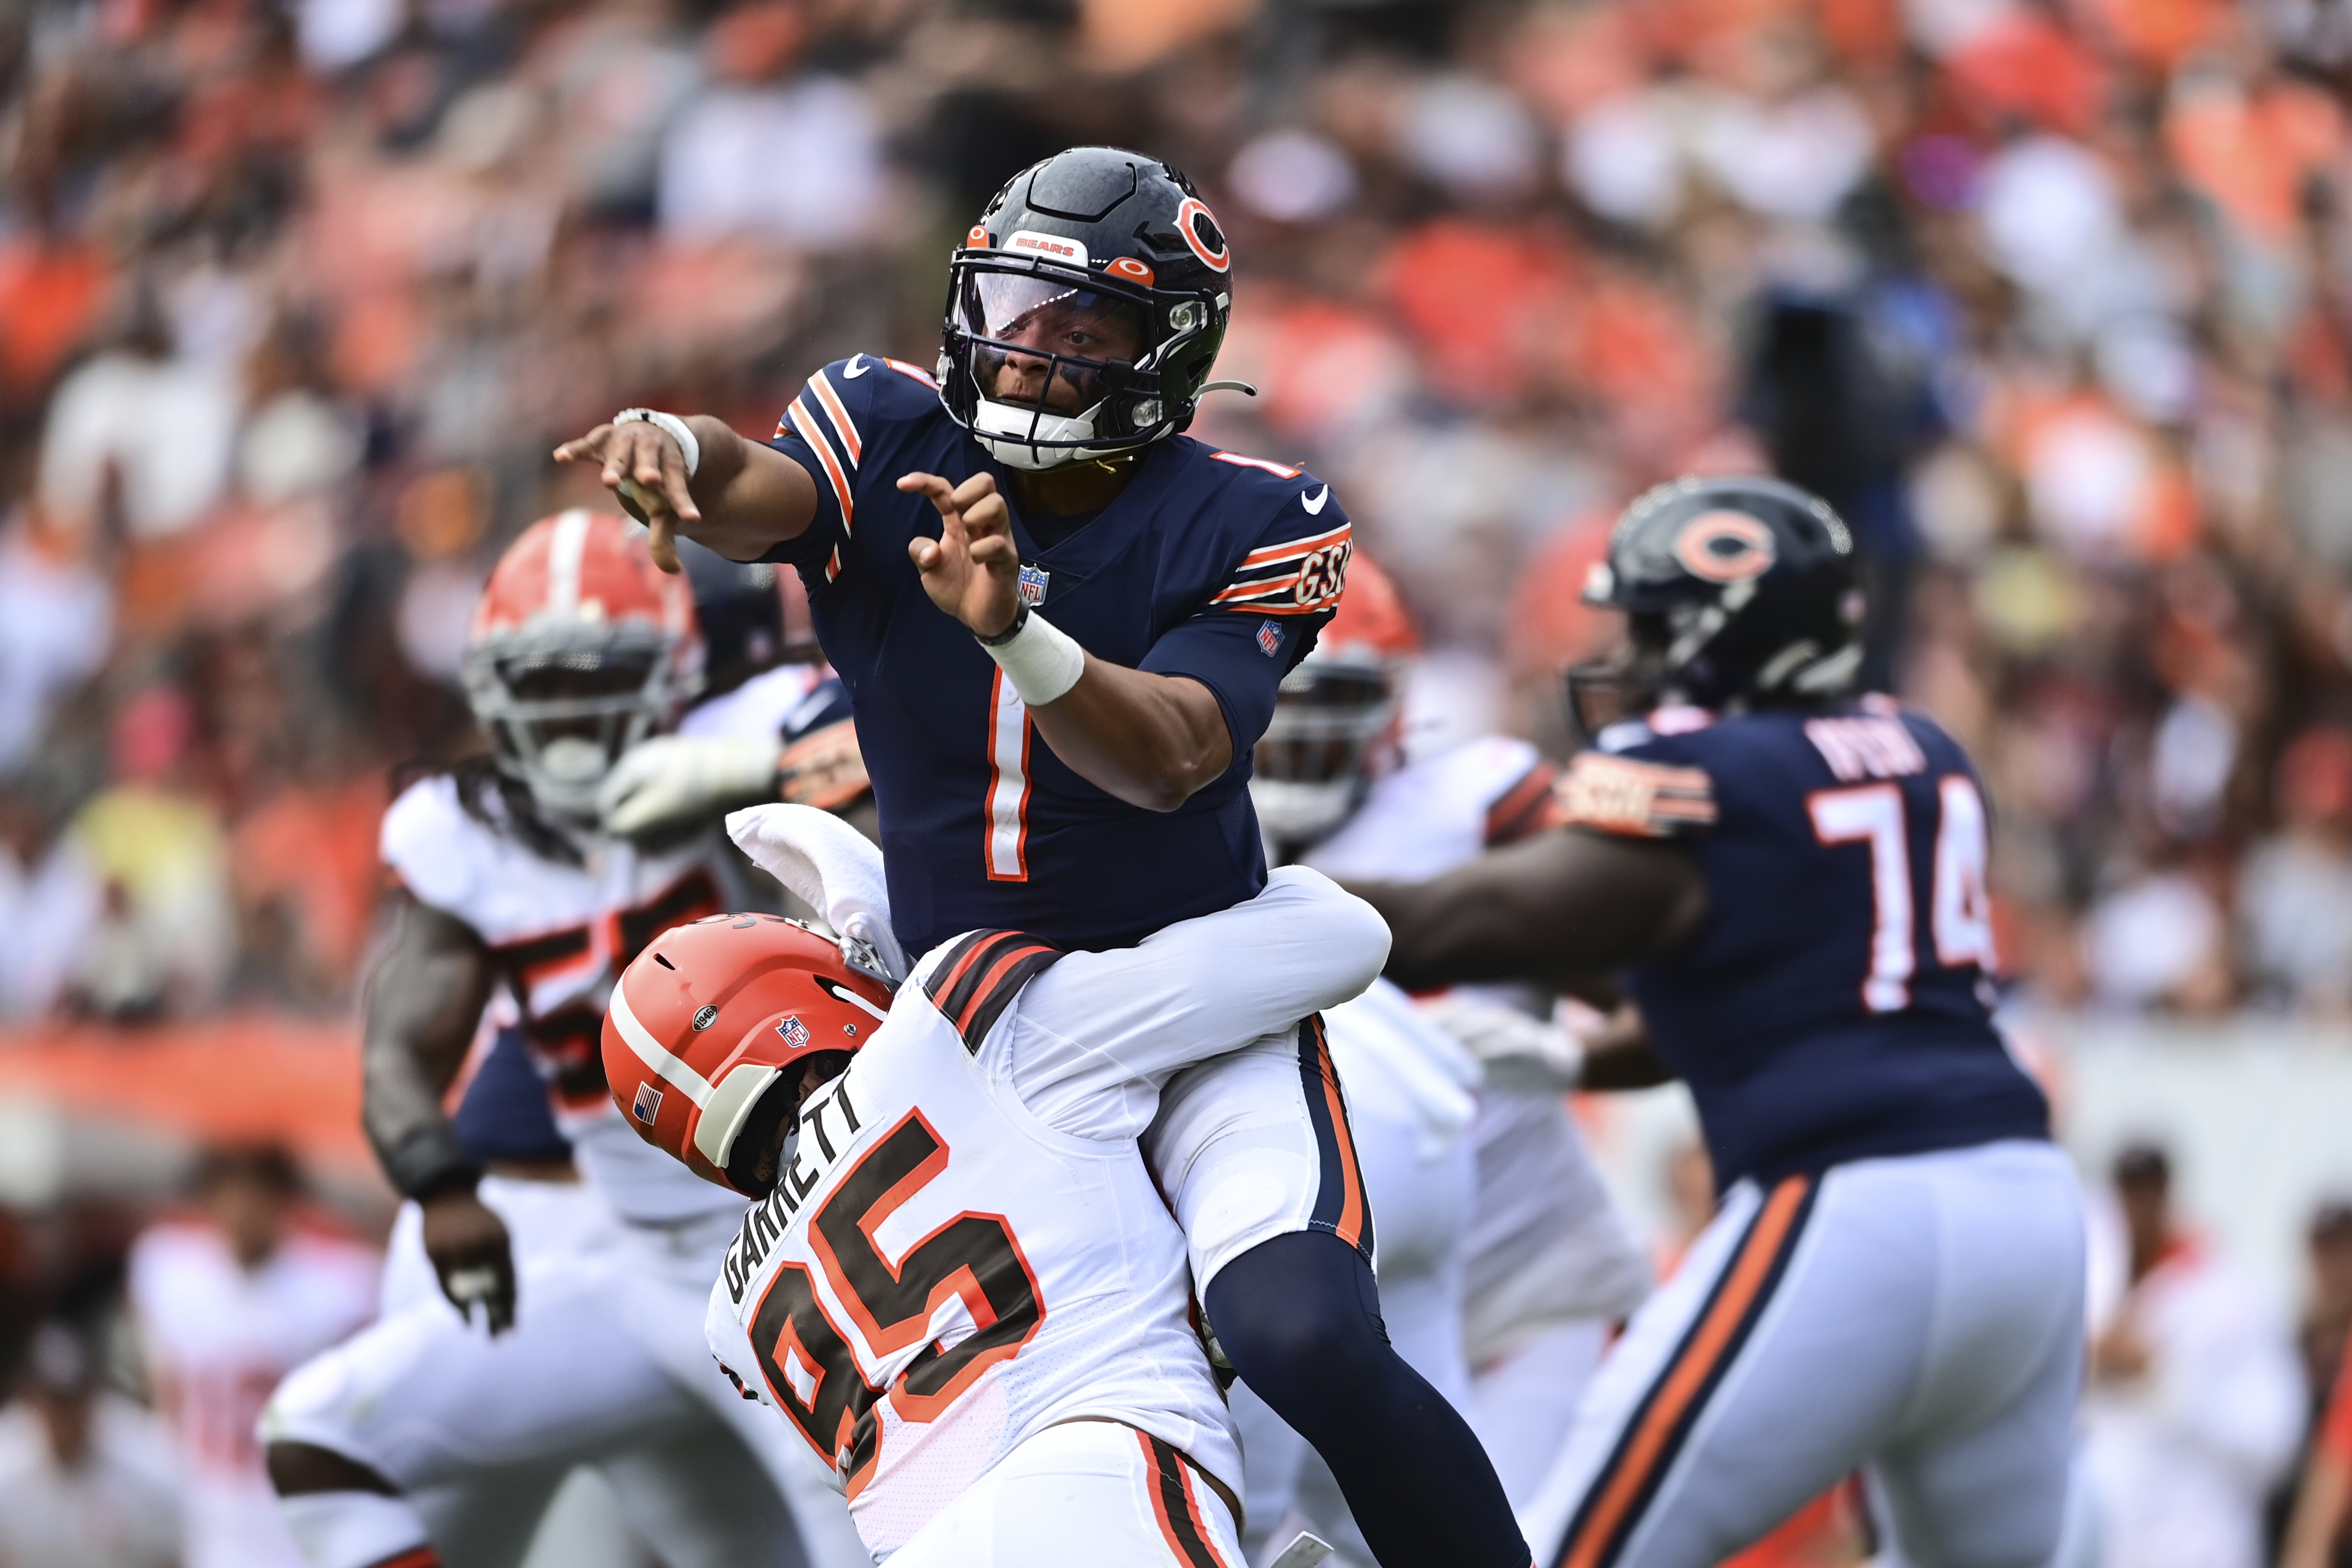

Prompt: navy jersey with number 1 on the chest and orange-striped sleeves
[{"left": 769, "top": 355, "right": 1350, "bottom": 952}]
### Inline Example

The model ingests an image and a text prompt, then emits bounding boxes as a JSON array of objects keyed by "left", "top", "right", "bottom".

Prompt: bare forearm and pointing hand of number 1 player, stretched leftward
[{"left": 555, "top": 414, "right": 816, "bottom": 571}]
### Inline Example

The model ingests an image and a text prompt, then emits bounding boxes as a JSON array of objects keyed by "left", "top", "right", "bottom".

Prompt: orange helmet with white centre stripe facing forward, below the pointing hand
[{"left": 463, "top": 508, "right": 703, "bottom": 820}]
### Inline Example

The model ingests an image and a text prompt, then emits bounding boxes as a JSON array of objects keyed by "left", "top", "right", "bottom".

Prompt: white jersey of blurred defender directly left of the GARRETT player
[{"left": 381, "top": 776, "right": 739, "bottom": 1225}]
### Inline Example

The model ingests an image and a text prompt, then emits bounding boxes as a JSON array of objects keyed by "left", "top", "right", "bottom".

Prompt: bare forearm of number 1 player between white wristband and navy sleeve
[{"left": 1030, "top": 658, "right": 1232, "bottom": 811}]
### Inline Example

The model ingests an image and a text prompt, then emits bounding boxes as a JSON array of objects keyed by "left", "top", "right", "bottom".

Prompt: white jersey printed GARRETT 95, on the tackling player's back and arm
[{"left": 708, "top": 867, "right": 1388, "bottom": 1556}]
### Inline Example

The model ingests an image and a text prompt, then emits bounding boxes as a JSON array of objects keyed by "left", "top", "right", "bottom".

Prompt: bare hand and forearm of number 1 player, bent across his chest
[{"left": 899, "top": 473, "right": 1232, "bottom": 811}]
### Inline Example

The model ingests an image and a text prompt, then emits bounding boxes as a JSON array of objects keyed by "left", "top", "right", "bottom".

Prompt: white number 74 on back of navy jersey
[{"left": 1806, "top": 773, "right": 1994, "bottom": 1013}]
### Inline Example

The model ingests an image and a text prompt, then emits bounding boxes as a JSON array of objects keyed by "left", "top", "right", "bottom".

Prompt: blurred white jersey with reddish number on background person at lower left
[{"left": 129, "top": 1222, "right": 376, "bottom": 1568}]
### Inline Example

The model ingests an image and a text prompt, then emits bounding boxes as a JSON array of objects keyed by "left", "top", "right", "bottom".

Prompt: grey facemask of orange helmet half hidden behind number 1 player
[{"left": 1249, "top": 658, "right": 1397, "bottom": 849}]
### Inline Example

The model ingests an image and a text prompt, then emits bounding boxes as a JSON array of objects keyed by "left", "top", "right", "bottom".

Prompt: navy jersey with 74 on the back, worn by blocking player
[{"left": 1559, "top": 698, "right": 2049, "bottom": 1185}]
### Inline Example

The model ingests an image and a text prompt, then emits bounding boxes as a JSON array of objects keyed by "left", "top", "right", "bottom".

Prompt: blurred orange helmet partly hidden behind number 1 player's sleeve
[{"left": 1249, "top": 550, "right": 1421, "bottom": 851}]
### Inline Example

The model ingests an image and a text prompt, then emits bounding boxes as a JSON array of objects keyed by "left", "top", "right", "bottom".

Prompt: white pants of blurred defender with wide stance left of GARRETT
[{"left": 261, "top": 1178, "right": 870, "bottom": 1568}]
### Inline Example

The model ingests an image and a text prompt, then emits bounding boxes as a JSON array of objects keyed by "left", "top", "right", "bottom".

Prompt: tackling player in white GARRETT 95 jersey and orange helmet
[{"left": 604, "top": 807, "right": 1388, "bottom": 1568}]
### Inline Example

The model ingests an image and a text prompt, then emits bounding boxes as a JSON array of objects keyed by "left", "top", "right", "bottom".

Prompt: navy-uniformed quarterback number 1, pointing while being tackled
[{"left": 555, "top": 148, "right": 1529, "bottom": 1568}]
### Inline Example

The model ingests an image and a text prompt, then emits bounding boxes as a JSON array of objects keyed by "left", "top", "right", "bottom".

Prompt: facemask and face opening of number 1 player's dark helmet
[{"left": 938, "top": 249, "right": 1221, "bottom": 470}]
